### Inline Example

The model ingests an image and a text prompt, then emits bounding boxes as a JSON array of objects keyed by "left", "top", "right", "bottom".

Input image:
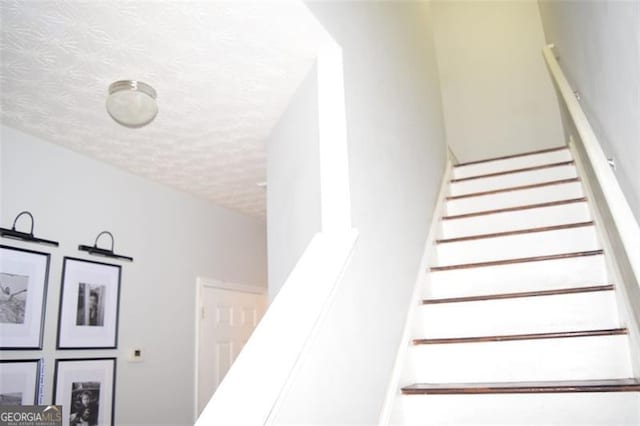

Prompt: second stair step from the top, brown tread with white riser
[{"left": 449, "top": 161, "right": 578, "bottom": 196}]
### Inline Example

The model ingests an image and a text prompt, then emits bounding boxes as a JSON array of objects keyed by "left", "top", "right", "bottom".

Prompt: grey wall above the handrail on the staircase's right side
[{"left": 539, "top": 1, "right": 640, "bottom": 221}]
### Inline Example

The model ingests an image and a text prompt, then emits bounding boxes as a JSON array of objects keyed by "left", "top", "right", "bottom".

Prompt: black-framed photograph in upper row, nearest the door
[{"left": 57, "top": 257, "right": 120, "bottom": 349}]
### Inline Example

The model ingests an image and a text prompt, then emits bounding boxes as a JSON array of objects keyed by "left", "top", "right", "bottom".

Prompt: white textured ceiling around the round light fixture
[{"left": 0, "top": 0, "right": 323, "bottom": 216}]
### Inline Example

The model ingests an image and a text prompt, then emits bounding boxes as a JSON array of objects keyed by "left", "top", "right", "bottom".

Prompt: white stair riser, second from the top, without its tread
[{"left": 449, "top": 165, "right": 577, "bottom": 195}]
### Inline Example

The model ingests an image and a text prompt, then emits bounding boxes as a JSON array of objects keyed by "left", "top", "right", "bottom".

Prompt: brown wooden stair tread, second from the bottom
[{"left": 413, "top": 328, "right": 627, "bottom": 345}]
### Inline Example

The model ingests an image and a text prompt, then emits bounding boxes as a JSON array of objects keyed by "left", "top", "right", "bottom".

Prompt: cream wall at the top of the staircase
[{"left": 432, "top": 0, "right": 566, "bottom": 162}]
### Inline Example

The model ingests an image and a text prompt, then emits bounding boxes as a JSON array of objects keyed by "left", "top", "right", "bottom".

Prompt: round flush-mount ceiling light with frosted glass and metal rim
[{"left": 107, "top": 80, "right": 158, "bottom": 128}]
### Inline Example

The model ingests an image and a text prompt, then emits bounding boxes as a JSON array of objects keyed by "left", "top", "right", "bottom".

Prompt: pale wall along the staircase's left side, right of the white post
[{"left": 274, "top": 2, "right": 446, "bottom": 424}]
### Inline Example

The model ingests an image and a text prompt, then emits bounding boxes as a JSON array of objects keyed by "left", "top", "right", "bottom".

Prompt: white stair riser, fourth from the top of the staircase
[{"left": 441, "top": 202, "right": 591, "bottom": 238}]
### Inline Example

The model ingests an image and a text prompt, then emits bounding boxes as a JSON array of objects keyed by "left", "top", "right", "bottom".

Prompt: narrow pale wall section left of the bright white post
[{"left": 267, "top": 66, "right": 320, "bottom": 300}]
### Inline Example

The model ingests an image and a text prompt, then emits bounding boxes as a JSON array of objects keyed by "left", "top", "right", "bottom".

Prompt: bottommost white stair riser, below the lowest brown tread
[{"left": 400, "top": 392, "right": 640, "bottom": 426}]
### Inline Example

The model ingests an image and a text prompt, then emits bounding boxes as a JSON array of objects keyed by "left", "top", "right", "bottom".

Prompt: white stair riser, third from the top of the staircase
[{"left": 446, "top": 182, "right": 584, "bottom": 215}]
